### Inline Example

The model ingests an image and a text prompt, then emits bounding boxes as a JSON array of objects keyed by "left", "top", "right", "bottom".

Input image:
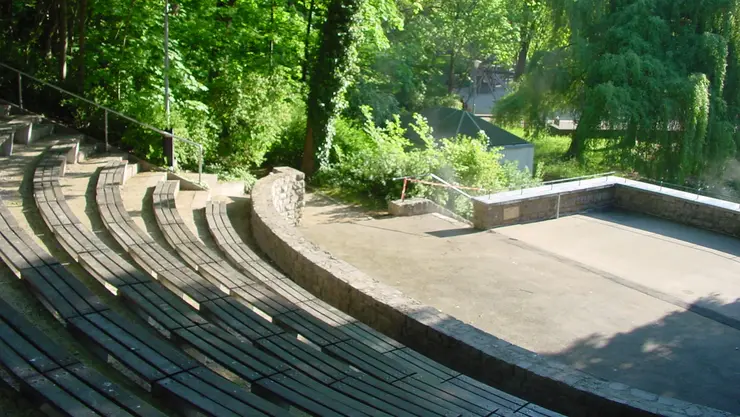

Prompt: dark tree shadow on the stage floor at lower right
[{"left": 543, "top": 296, "right": 740, "bottom": 414}]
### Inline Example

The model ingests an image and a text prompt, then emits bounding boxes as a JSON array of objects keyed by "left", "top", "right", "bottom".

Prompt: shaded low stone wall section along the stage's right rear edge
[{"left": 614, "top": 185, "right": 740, "bottom": 237}]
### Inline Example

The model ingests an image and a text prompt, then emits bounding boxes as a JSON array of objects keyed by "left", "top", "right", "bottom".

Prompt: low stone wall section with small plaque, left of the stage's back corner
[{"left": 473, "top": 184, "right": 614, "bottom": 230}]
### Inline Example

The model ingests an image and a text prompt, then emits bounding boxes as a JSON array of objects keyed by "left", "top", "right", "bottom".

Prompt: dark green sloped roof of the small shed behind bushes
[{"left": 403, "top": 107, "right": 530, "bottom": 147}]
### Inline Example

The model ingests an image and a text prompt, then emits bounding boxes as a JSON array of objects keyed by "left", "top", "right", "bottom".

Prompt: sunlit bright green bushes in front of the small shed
[{"left": 317, "top": 107, "right": 541, "bottom": 214}]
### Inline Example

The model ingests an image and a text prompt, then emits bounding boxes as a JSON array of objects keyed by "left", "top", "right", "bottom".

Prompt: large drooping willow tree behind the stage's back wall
[{"left": 496, "top": 0, "right": 740, "bottom": 181}]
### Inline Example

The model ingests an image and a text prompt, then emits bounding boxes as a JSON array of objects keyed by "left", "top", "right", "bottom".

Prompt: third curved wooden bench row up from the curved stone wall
[{"left": 96, "top": 162, "right": 408, "bottom": 415}]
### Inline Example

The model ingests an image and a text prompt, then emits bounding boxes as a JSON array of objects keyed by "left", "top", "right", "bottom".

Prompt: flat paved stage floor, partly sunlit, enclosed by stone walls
[{"left": 301, "top": 195, "right": 740, "bottom": 414}]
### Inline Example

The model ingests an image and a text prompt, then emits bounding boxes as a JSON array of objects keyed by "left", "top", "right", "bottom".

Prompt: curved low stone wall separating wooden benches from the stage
[{"left": 251, "top": 168, "right": 732, "bottom": 417}]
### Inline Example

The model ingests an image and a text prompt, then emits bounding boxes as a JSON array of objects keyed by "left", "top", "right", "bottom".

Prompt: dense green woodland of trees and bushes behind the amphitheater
[{"left": 0, "top": 0, "right": 740, "bottom": 210}]
